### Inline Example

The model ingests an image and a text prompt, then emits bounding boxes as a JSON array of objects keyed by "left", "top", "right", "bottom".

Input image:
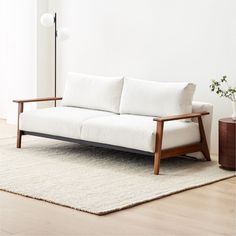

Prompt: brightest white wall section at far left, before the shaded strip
[{"left": 0, "top": 0, "right": 36, "bottom": 123}]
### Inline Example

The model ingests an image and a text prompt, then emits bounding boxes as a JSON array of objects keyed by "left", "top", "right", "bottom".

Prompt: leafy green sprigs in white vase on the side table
[{"left": 210, "top": 75, "right": 236, "bottom": 121}]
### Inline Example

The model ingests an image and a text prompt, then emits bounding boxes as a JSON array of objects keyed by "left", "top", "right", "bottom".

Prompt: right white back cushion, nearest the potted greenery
[{"left": 120, "top": 78, "right": 196, "bottom": 116}]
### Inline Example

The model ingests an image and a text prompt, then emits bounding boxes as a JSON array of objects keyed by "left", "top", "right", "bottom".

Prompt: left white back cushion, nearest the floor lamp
[{"left": 62, "top": 73, "right": 123, "bottom": 113}]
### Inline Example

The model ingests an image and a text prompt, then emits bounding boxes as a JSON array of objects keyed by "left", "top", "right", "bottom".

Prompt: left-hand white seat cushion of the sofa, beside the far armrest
[{"left": 20, "top": 107, "right": 115, "bottom": 139}]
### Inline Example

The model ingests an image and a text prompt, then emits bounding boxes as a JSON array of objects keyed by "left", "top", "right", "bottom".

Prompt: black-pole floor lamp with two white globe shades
[{"left": 40, "top": 13, "right": 69, "bottom": 106}]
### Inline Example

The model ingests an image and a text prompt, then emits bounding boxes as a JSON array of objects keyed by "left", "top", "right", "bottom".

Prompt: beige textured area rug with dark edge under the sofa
[{"left": 0, "top": 136, "right": 235, "bottom": 215}]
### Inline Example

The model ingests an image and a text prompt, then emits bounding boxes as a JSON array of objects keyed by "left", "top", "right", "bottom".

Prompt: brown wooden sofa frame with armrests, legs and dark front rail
[{"left": 13, "top": 97, "right": 211, "bottom": 175}]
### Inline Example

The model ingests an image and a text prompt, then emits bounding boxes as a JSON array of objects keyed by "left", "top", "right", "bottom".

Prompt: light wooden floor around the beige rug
[{"left": 0, "top": 120, "right": 236, "bottom": 236}]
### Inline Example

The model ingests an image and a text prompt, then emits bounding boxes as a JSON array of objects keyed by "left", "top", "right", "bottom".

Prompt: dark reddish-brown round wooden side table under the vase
[{"left": 219, "top": 118, "right": 236, "bottom": 170}]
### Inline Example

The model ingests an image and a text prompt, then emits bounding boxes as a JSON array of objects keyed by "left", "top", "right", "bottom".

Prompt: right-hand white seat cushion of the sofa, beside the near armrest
[{"left": 81, "top": 115, "right": 200, "bottom": 152}]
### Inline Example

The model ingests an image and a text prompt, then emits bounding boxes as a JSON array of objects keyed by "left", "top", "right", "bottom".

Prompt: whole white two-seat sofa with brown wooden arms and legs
[{"left": 14, "top": 73, "right": 212, "bottom": 174}]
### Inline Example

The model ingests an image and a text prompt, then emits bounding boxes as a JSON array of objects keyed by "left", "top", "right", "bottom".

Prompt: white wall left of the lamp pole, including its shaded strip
[{"left": 0, "top": 0, "right": 54, "bottom": 123}]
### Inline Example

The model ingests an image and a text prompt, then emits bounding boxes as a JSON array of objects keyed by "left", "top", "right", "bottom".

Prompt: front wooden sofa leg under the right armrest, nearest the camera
[{"left": 154, "top": 121, "right": 164, "bottom": 175}]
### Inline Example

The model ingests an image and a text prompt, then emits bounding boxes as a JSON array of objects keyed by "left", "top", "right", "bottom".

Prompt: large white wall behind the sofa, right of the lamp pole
[{"left": 51, "top": 0, "right": 236, "bottom": 153}]
